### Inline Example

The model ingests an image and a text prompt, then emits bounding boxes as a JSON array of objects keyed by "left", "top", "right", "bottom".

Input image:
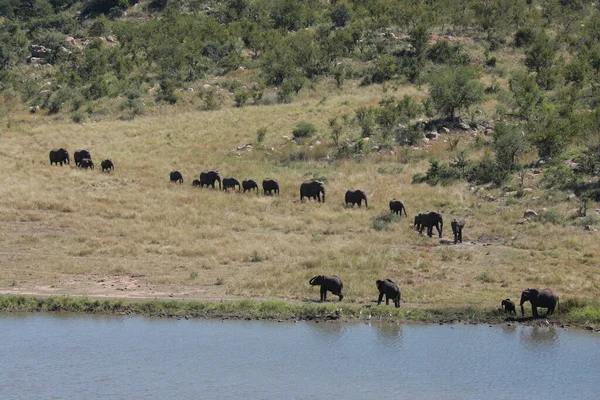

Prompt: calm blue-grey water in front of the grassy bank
[{"left": 0, "top": 314, "right": 600, "bottom": 400}]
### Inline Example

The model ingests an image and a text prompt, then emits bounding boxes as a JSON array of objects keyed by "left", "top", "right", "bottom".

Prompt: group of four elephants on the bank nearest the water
[{"left": 308, "top": 275, "right": 558, "bottom": 318}]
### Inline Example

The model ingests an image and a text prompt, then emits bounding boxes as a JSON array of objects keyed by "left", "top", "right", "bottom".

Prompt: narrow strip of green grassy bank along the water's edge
[{"left": 0, "top": 295, "right": 600, "bottom": 332}]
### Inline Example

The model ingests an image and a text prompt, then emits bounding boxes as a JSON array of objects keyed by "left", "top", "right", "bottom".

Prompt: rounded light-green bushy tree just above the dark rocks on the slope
[{"left": 429, "top": 66, "right": 484, "bottom": 118}]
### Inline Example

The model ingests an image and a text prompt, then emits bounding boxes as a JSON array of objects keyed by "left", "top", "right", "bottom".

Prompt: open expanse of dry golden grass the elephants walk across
[{"left": 0, "top": 86, "right": 600, "bottom": 307}]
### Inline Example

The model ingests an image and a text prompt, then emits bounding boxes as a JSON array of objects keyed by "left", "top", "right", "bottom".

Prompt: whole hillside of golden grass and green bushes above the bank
[{"left": 0, "top": 0, "right": 600, "bottom": 324}]
